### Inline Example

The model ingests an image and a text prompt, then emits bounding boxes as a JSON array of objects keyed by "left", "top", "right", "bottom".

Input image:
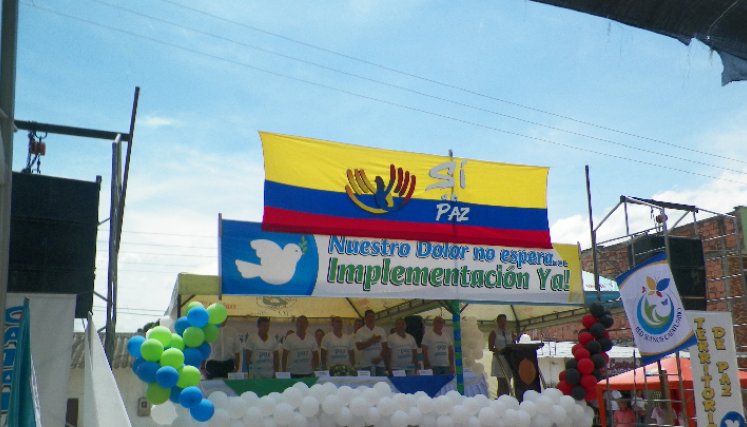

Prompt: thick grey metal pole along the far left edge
[{"left": 0, "top": 0, "right": 18, "bottom": 364}]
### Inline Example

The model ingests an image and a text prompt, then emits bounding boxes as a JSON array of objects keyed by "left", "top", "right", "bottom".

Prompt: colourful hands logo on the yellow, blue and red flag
[{"left": 345, "top": 164, "right": 416, "bottom": 215}]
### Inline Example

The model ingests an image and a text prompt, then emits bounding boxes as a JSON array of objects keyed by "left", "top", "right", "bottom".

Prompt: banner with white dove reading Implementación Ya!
[{"left": 220, "top": 220, "right": 583, "bottom": 305}]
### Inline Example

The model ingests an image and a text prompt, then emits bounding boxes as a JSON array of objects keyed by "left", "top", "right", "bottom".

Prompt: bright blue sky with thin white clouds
[{"left": 14, "top": 0, "right": 747, "bottom": 330}]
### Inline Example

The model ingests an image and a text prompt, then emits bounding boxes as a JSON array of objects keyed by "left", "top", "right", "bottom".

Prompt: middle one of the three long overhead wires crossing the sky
[{"left": 90, "top": 0, "right": 747, "bottom": 174}]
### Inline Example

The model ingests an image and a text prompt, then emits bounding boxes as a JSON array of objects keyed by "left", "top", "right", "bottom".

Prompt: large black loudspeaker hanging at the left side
[{"left": 8, "top": 173, "right": 101, "bottom": 318}]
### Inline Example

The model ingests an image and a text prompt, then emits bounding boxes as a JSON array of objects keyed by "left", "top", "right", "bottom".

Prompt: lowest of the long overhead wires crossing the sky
[{"left": 21, "top": 1, "right": 747, "bottom": 185}]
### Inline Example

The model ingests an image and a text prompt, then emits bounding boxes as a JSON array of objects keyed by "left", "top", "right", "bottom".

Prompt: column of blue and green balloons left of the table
[{"left": 127, "top": 301, "right": 228, "bottom": 421}]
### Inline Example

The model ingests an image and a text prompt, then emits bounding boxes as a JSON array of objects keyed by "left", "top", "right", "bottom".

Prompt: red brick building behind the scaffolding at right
[{"left": 530, "top": 203, "right": 747, "bottom": 368}]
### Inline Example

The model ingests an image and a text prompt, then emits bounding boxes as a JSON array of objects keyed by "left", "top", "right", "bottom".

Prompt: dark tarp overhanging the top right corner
[{"left": 533, "top": 0, "right": 747, "bottom": 84}]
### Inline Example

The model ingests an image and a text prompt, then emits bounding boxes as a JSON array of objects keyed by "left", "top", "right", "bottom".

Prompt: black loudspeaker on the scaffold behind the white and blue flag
[{"left": 628, "top": 236, "right": 706, "bottom": 310}]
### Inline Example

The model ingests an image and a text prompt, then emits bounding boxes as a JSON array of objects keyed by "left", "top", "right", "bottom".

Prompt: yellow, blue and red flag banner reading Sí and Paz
[{"left": 260, "top": 132, "right": 552, "bottom": 248}]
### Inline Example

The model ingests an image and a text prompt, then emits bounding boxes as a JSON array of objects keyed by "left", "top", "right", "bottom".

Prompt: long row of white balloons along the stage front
[{"left": 151, "top": 382, "right": 594, "bottom": 427}]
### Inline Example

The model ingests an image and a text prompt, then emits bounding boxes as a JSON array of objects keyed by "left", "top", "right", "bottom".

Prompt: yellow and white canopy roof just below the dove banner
[{"left": 168, "top": 273, "right": 620, "bottom": 328}]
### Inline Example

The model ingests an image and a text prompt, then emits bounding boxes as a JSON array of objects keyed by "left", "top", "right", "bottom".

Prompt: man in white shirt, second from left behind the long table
[{"left": 282, "top": 316, "right": 319, "bottom": 378}]
